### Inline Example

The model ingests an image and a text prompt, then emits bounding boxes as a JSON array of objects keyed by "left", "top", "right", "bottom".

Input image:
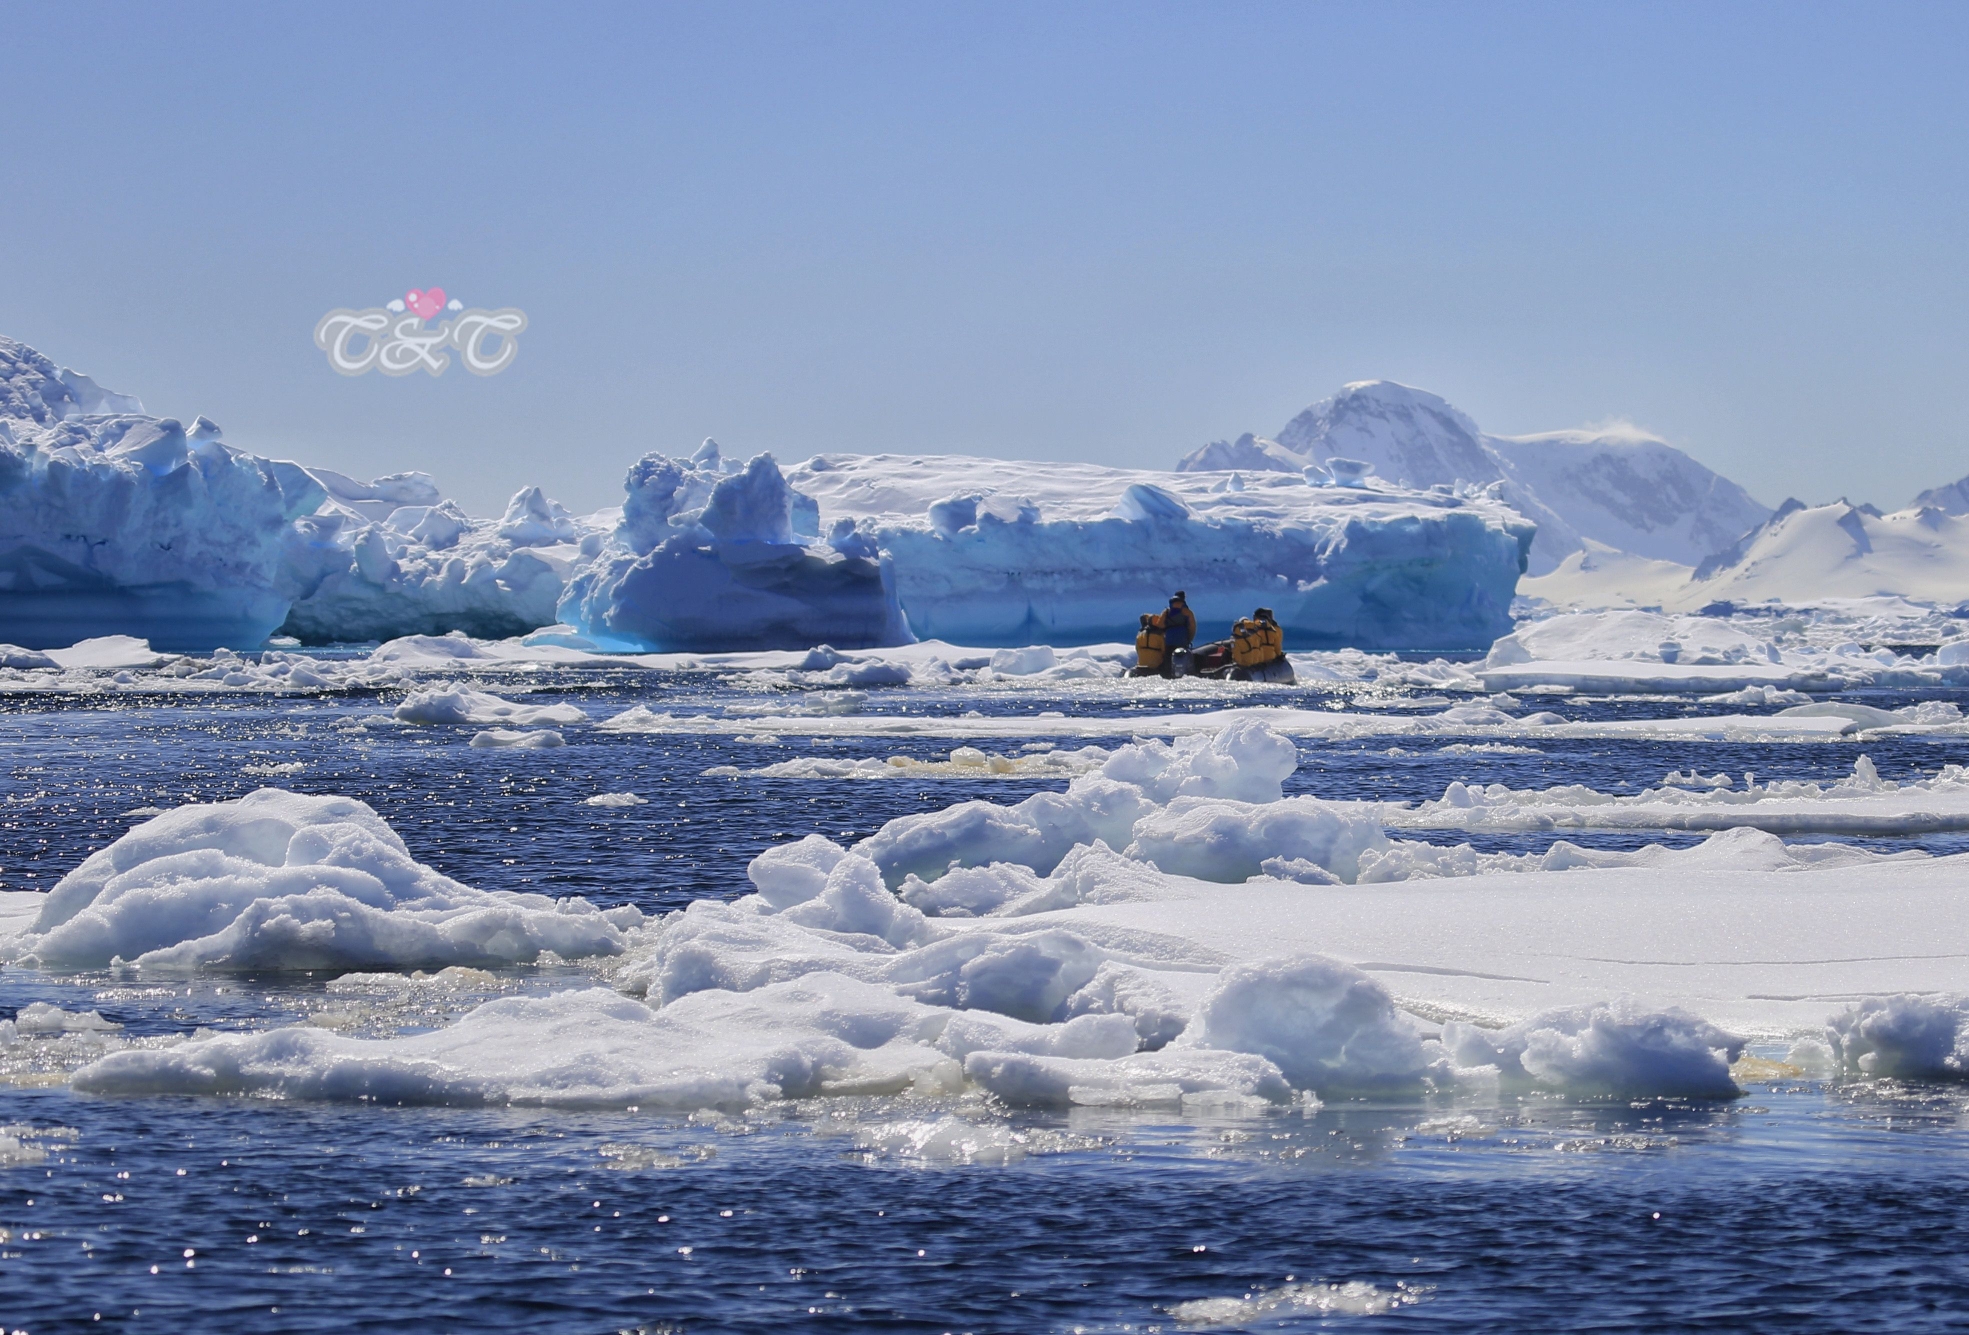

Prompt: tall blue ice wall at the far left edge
[{"left": 0, "top": 339, "right": 323, "bottom": 650}]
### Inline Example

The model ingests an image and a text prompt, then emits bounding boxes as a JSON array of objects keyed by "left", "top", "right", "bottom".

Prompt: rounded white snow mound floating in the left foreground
[{"left": 0, "top": 788, "right": 640, "bottom": 969}]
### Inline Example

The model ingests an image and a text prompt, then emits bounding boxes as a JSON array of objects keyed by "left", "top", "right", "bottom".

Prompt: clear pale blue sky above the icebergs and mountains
[{"left": 0, "top": 0, "right": 1969, "bottom": 512}]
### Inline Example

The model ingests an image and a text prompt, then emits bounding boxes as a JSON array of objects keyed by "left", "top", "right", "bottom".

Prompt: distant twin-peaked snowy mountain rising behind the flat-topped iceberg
[{"left": 1177, "top": 380, "right": 1770, "bottom": 575}]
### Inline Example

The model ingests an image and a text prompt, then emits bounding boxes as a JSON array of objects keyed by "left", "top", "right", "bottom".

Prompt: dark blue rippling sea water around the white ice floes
[{"left": 0, "top": 671, "right": 1969, "bottom": 1333}]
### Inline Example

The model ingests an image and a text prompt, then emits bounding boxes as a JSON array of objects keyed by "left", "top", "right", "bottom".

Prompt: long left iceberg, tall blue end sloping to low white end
[{"left": 0, "top": 339, "right": 612, "bottom": 650}]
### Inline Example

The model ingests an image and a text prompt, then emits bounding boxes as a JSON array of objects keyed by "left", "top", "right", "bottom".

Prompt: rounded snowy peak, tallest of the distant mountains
[{"left": 1278, "top": 380, "right": 1502, "bottom": 486}]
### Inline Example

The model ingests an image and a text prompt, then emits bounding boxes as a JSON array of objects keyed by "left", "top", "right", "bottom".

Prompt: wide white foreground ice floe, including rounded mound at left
[{"left": 38, "top": 723, "right": 1969, "bottom": 1118}]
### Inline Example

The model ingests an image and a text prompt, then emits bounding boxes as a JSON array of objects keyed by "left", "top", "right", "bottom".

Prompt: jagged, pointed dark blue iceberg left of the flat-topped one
[{"left": 561, "top": 441, "right": 912, "bottom": 650}]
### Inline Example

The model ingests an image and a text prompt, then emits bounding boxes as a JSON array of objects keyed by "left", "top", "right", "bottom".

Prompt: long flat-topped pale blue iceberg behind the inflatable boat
[{"left": 786, "top": 455, "right": 1534, "bottom": 650}]
